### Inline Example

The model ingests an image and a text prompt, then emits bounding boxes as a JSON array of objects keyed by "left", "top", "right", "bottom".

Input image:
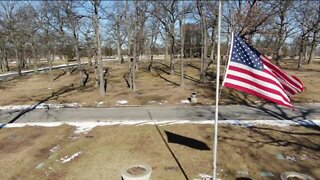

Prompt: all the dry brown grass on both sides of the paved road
[{"left": 0, "top": 60, "right": 320, "bottom": 180}]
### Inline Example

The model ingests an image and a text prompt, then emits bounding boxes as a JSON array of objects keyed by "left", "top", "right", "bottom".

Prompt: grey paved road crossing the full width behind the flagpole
[{"left": 0, "top": 104, "right": 320, "bottom": 123}]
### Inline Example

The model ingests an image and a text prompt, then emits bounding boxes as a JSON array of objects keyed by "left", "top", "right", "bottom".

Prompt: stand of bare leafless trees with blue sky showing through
[{"left": 0, "top": 0, "right": 320, "bottom": 96}]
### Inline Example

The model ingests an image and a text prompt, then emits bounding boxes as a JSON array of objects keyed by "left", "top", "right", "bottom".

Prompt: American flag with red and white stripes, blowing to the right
[{"left": 223, "top": 36, "right": 304, "bottom": 108}]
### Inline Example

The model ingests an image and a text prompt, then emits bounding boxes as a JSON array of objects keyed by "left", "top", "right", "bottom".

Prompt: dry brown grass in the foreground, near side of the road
[{"left": 0, "top": 125, "right": 320, "bottom": 180}]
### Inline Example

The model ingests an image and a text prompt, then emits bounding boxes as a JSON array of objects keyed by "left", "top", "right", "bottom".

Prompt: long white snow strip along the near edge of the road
[{"left": 0, "top": 120, "right": 320, "bottom": 134}]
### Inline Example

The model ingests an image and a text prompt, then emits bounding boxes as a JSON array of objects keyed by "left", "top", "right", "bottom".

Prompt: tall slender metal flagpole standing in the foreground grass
[{"left": 213, "top": 0, "right": 221, "bottom": 180}]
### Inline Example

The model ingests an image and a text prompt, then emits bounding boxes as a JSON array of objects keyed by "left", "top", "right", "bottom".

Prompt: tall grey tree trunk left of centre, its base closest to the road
[{"left": 94, "top": 0, "right": 106, "bottom": 96}]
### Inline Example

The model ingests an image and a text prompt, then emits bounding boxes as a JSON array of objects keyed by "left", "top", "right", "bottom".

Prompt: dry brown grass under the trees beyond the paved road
[{"left": 0, "top": 59, "right": 320, "bottom": 107}]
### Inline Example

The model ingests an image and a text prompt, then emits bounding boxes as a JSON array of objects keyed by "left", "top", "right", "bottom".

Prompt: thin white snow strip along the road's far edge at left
[{"left": 0, "top": 103, "right": 81, "bottom": 110}]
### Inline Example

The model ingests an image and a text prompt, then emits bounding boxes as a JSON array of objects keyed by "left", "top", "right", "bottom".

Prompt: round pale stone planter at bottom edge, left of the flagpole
[{"left": 121, "top": 164, "right": 152, "bottom": 180}]
